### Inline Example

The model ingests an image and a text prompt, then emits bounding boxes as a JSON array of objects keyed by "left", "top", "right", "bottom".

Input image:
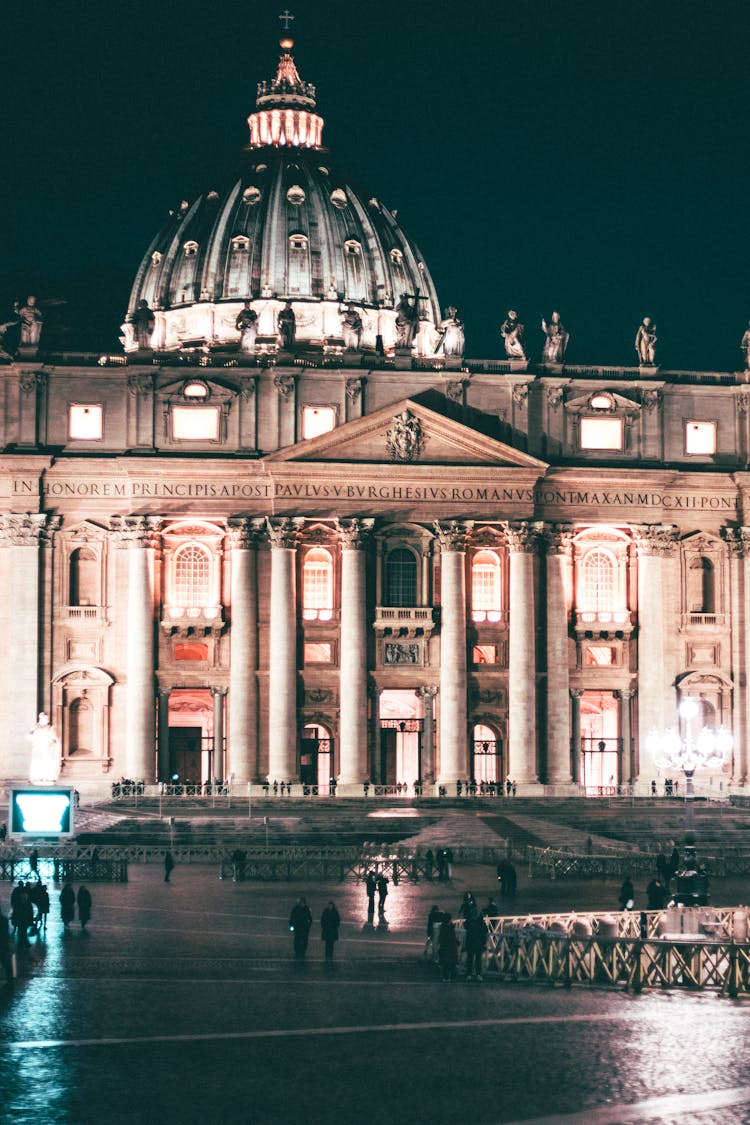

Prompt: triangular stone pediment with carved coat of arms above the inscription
[{"left": 264, "top": 398, "right": 548, "bottom": 473}]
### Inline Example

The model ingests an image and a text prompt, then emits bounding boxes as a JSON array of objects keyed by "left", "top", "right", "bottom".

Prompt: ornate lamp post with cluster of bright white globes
[{"left": 645, "top": 699, "right": 734, "bottom": 906}]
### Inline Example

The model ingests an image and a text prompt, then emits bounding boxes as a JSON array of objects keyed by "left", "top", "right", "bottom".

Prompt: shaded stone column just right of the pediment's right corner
[{"left": 541, "top": 524, "right": 572, "bottom": 785}]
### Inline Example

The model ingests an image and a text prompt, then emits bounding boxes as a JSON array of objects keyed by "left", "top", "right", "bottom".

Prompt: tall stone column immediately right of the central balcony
[{"left": 435, "top": 520, "right": 473, "bottom": 785}]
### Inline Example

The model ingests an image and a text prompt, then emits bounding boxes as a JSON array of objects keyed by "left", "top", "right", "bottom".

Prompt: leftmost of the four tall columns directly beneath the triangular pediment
[{"left": 265, "top": 519, "right": 304, "bottom": 781}]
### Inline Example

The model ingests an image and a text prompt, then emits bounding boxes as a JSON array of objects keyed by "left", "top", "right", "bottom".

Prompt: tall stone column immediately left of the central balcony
[{"left": 336, "top": 520, "right": 374, "bottom": 785}]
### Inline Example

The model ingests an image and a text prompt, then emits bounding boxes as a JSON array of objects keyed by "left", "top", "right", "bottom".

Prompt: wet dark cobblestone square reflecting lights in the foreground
[{"left": 0, "top": 866, "right": 750, "bottom": 1125}]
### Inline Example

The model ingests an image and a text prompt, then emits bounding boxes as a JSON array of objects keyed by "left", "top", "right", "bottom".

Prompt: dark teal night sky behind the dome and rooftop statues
[{"left": 0, "top": 0, "right": 750, "bottom": 370}]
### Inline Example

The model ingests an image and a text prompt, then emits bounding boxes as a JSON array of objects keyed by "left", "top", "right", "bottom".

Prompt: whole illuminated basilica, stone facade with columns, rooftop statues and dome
[{"left": 0, "top": 32, "right": 750, "bottom": 795}]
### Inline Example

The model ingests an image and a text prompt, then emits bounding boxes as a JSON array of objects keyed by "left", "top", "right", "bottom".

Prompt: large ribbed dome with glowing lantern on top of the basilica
[{"left": 123, "top": 38, "right": 440, "bottom": 354}]
